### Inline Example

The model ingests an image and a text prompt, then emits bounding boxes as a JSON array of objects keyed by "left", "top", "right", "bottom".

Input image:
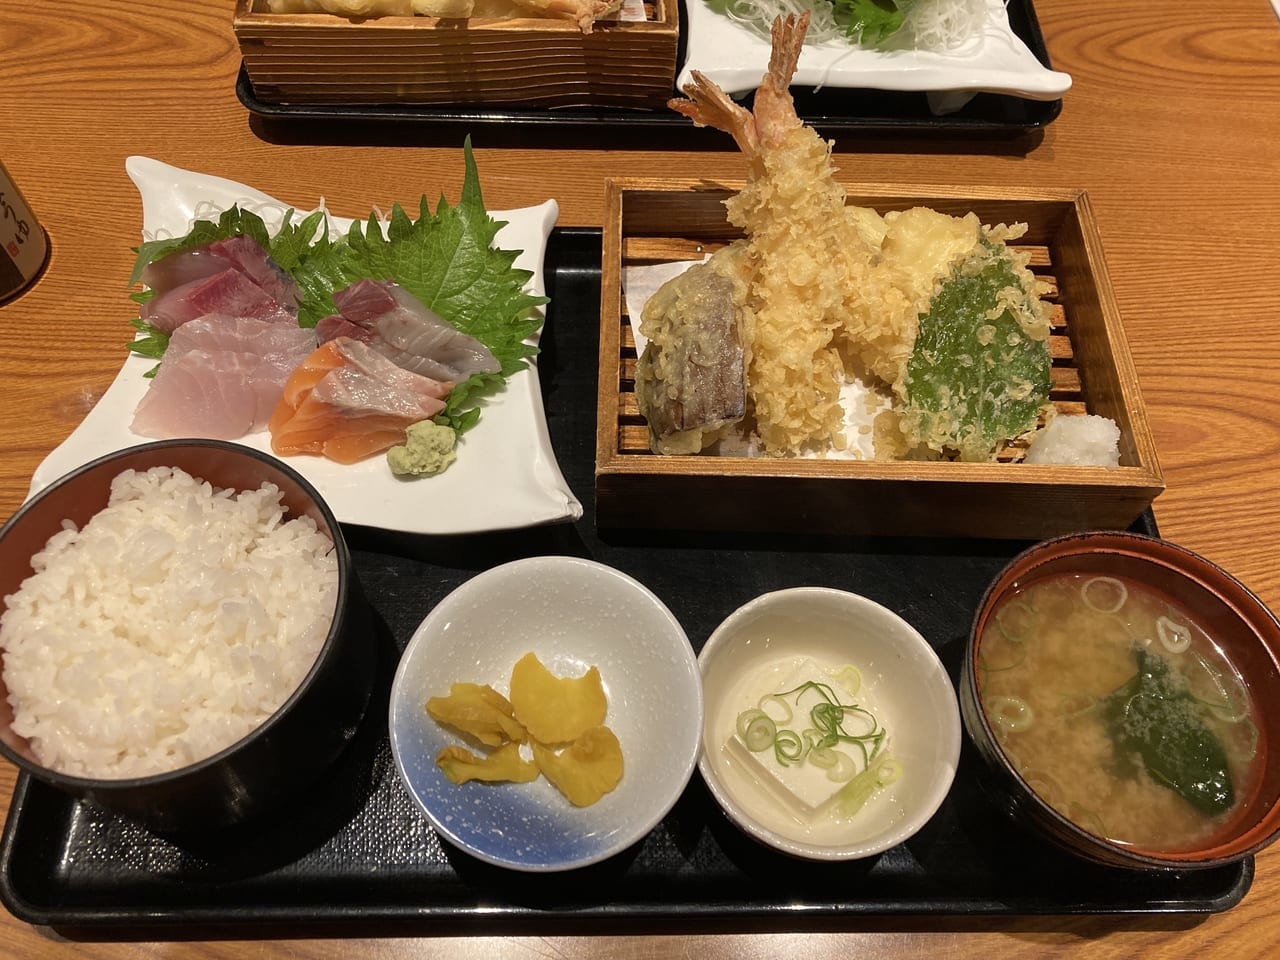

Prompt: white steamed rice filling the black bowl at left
[{"left": 0, "top": 467, "right": 338, "bottom": 778}]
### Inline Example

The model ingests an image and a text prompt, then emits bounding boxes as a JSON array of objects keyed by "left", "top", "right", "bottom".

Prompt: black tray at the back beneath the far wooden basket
[{"left": 236, "top": 0, "right": 1062, "bottom": 148}]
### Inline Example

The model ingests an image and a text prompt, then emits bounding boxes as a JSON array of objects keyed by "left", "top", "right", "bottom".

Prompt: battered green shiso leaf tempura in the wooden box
[{"left": 902, "top": 241, "right": 1050, "bottom": 461}]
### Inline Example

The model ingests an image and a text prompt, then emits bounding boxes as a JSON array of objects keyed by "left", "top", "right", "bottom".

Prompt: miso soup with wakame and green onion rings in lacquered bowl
[{"left": 975, "top": 573, "right": 1258, "bottom": 852}]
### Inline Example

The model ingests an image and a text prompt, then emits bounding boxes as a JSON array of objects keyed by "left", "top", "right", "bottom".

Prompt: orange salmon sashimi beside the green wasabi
[{"left": 268, "top": 337, "right": 453, "bottom": 463}]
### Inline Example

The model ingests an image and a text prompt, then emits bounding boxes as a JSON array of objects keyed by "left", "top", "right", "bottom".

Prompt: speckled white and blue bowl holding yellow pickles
[{"left": 390, "top": 557, "right": 703, "bottom": 872}]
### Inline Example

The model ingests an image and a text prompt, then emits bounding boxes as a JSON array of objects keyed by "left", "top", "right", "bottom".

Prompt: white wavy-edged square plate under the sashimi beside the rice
[{"left": 31, "top": 156, "right": 582, "bottom": 534}]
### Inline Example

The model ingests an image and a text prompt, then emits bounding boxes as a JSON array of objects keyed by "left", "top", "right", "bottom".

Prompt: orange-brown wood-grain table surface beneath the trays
[{"left": 0, "top": 0, "right": 1280, "bottom": 960}]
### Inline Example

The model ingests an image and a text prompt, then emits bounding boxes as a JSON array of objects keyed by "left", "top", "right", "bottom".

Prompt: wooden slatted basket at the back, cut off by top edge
[{"left": 233, "top": 0, "right": 680, "bottom": 110}]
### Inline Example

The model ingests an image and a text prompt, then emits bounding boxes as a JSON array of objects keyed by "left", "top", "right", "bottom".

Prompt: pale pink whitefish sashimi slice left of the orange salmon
[{"left": 131, "top": 315, "right": 316, "bottom": 440}]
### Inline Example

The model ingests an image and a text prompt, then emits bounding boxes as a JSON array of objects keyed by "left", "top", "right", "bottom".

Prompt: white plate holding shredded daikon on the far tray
[{"left": 677, "top": 0, "right": 1071, "bottom": 106}]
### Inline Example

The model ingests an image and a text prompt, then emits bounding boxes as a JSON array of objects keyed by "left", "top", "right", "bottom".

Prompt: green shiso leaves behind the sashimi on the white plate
[{"left": 129, "top": 137, "right": 547, "bottom": 434}]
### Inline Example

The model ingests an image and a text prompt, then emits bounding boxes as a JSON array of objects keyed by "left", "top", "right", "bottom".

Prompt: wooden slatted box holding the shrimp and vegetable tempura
[{"left": 595, "top": 179, "right": 1165, "bottom": 539}]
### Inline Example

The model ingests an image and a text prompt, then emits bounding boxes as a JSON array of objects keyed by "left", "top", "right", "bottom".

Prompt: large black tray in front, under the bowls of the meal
[{"left": 0, "top": 229, "right": 1253, "bottom": 938}]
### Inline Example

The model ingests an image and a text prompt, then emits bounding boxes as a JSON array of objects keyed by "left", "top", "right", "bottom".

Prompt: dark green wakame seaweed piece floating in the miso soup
[{"left": 1102, "top": 646, "right": 1235, "bottom": 814}]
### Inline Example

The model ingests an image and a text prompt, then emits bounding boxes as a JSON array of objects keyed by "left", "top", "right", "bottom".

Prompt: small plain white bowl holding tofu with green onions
[{"left": 698, "top": 588, "right": 960, "bottom": 860}]
